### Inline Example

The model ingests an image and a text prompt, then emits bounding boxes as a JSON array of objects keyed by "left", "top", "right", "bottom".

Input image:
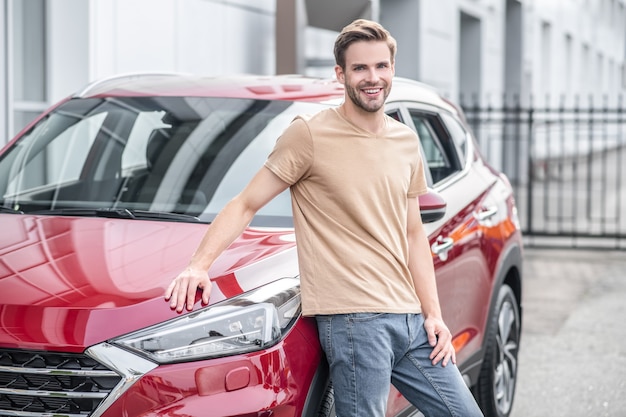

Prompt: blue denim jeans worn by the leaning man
[{"left": 315, "top": 313, "right": 483, "bottom": 417}]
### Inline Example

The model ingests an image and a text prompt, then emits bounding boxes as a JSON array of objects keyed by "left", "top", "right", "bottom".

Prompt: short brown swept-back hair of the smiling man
[{"left": 334, "top": 19, "right": 397, "bottom": 69}]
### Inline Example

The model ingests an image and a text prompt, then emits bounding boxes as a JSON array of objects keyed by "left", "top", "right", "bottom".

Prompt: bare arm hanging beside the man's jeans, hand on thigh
[{"left": 407, "top": 197, "right": 456, "bottom": 366}]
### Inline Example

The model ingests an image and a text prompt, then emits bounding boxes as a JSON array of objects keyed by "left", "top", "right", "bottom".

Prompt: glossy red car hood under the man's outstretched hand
[{"left": 0, "top": 214, "right": 298, "bottom": 352}]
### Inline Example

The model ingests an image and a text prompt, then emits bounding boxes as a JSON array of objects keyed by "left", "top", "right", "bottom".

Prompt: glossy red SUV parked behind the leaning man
[{"left": 0, "top": 74, "right": 522, "bottom": 417}]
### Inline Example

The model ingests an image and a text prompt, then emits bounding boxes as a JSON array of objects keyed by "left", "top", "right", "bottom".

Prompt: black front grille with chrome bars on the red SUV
[{"left": 0, "top": 349, "right": 121, "bottom": 417}]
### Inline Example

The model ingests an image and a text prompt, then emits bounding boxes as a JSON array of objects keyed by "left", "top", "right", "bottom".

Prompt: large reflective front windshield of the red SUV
[{"left": 0, "top": 97, "right": 330, "bottom": 226}]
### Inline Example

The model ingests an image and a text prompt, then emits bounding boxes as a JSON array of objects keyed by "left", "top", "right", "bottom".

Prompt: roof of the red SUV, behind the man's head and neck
[{"left": 73, "top": 73, "right": 456, "bottom": 112}]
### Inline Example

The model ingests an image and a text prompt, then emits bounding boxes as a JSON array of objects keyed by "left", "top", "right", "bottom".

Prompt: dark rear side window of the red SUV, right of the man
[{"left": 410, "top": 109, "right": 462, "bottom": 184}]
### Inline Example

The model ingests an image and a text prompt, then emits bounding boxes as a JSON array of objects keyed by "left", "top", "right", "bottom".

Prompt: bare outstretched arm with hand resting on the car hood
[{"left": 165, "top": 167, "right": 289, "bottom": 313}]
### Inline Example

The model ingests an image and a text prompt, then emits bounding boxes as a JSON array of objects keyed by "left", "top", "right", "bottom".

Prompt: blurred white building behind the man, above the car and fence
[{"left": 0, "top": 0, "right": 626, "bottom": 146}]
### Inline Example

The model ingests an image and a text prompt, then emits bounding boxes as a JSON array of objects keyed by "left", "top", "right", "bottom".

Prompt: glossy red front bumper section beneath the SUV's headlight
[{"left": 97, "top": 319, "right": 321, "bottom": 417}]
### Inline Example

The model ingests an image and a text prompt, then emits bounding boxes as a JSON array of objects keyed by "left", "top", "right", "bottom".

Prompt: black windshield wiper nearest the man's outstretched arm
[{"left": 29, "top": 208, "right": 201, "bottom": 222}]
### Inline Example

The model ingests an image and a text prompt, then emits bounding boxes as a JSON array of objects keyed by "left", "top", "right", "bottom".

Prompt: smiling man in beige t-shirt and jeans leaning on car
[{"left": 165, "top": 20, "right": 482, "bottom": 417}]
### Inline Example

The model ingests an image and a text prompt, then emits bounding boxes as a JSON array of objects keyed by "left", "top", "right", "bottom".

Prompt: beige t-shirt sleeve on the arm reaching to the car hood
[{"left": 265, "top": 116, "right": 313, "bottom": 185}]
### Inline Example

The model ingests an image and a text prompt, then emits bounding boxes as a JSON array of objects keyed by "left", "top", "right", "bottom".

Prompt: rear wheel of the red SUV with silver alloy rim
[{"left": 476, "top": 284, "right": 521, "bottom": 417}]
